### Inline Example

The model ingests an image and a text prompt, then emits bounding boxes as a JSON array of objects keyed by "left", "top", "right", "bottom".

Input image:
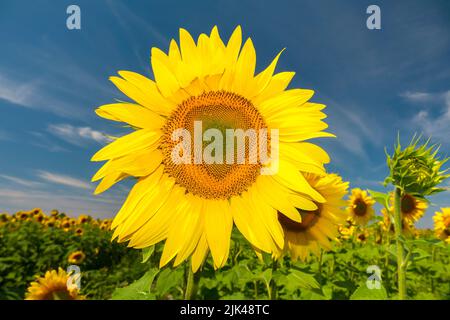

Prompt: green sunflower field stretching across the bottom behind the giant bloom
[{"left": 0, "top": 205, "right": 450, "bottom": 300}]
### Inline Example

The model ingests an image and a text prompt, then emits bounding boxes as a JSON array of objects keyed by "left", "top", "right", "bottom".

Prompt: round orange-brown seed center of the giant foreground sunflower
[{"left": 161, "top": 91, "right": 270, "bottom": 199}]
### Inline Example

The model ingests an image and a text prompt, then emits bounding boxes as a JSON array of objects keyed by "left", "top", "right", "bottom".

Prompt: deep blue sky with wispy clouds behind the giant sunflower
[{"left": 0, "top": 0, "right": 450, "bottom": 227}]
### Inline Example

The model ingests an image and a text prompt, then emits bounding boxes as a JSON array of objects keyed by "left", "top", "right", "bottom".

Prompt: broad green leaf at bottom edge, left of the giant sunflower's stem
[{"left": 111, "top": 268, "right": 159, "bottom": 300}]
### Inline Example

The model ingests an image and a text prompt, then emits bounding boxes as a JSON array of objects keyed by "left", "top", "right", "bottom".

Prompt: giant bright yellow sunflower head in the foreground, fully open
[{"left": 92, "top": 27, "right": 333, "bottom": 271}]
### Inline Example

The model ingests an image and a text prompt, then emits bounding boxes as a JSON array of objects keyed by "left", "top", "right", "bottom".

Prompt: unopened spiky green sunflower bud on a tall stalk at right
[{"left": 384, "top": 137, "right": 450, "bottom": 197}]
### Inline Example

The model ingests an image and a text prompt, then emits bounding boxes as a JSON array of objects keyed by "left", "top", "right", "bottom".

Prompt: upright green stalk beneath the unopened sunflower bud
[{"left": 394, "top": 187, "right": 406, "bottom": 300}]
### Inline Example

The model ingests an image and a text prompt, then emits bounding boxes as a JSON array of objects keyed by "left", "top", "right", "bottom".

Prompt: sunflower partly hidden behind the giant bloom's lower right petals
[{"left": 274, "top": 174, "right": 348, "bottom": 260}]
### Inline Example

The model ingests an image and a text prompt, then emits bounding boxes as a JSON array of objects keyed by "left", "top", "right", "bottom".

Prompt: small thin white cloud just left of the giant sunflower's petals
[{"left": 47, "top": 123, "right": 111, "bottom": 146}]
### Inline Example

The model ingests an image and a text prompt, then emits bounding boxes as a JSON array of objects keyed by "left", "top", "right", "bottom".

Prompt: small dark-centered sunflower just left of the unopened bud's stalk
[{"left": 347, "top": 188, "right": 375, "bottom": 226}]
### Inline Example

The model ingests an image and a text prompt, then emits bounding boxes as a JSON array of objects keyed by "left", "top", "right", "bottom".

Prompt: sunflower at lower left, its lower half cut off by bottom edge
[{"left": 25, "top": 268, "right": 84, "bottom": 300}]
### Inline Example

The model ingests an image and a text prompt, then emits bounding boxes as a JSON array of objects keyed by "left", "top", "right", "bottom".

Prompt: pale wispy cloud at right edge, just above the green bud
[{"left": 405, "top": 90, "right": 450, "bottom": 144}]
